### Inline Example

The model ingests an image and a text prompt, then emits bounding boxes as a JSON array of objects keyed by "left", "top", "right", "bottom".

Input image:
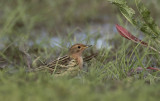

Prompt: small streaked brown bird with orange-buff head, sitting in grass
[{"left": 32, "top": 43, "right": 92, "bottom": 74}]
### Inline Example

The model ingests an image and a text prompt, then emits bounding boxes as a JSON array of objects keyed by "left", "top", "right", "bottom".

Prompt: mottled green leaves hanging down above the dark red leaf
[{"left": 108, "top": 0, "right": 160, "bottom": 39}]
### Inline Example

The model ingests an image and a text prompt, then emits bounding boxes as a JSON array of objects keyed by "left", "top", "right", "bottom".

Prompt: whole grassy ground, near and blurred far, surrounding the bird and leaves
[{"left": 0, "top": 0, "right": 160, "bottom": 101}]
